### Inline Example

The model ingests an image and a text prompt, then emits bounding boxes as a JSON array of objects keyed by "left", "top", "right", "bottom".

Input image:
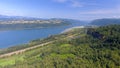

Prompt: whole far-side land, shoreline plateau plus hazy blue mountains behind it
[{"left": 0, "top": 15, "right": 84, "bottom": 30}]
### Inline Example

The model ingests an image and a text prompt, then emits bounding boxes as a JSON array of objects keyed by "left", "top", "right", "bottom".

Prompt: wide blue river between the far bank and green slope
[{"left": 0, "top": 23, "right": 83, "bottom": 48}]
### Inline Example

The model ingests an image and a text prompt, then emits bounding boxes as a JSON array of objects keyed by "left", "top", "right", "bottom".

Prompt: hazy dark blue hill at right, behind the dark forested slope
[{"left": 90, "top": 18, "right": 120, "bottom": 26}]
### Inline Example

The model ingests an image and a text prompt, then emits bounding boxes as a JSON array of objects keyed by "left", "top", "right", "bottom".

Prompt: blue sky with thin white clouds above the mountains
[{"left": 0, "top": 0, "right": 120, "bottom": 20}]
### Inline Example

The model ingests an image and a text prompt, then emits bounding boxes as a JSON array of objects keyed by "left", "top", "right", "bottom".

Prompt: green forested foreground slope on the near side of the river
[{"left": 0, "top": 25, "right": 120, "bottom": 68}]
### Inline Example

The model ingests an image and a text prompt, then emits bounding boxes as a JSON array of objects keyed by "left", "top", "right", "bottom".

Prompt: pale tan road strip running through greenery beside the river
[{"left": 0, "top": 41, "right": 53, "bottom": 58}]
